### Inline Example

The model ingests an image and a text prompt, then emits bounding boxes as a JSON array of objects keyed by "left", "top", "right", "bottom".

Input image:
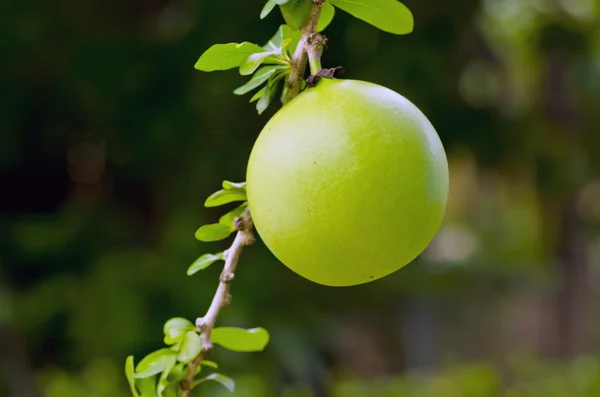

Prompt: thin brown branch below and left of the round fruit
[{"left": 180, "top": 209, "right": 255, "bottom": 397}]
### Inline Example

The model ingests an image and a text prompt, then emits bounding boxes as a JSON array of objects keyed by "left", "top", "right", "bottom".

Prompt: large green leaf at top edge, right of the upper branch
[{"left": 327, "top": 0, "right": 414, "bottom": 34}]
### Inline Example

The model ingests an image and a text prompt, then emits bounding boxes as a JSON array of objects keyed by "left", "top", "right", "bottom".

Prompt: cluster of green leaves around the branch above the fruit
[{"left": 195, "top": 0, "right": 414, "bottom": 114}]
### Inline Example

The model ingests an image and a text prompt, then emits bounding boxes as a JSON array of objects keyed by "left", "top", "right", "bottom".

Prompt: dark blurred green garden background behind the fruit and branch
[{"left": 0, "top": 0, "right": 600, "bottom": 397}]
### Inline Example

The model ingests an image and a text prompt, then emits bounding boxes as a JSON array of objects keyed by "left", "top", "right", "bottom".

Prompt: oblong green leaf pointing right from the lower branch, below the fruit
[{"left": 210, "top": 327, "right": 269, "bottom": 352}]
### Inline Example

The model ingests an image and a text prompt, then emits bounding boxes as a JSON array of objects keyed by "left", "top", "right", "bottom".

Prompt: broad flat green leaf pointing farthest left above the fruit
[{"left": 194, "top": 41, "right": 264, "bottom": 72}]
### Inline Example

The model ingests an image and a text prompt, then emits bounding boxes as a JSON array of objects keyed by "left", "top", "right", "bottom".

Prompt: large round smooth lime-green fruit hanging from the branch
[{"left": 246, "top": 79, "right": 448, "bottom": 286}]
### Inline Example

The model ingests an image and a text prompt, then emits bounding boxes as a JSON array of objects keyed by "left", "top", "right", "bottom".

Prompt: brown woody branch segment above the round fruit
[{"left": 284, "top": 0, "right": 324, "bottom": 103}]
